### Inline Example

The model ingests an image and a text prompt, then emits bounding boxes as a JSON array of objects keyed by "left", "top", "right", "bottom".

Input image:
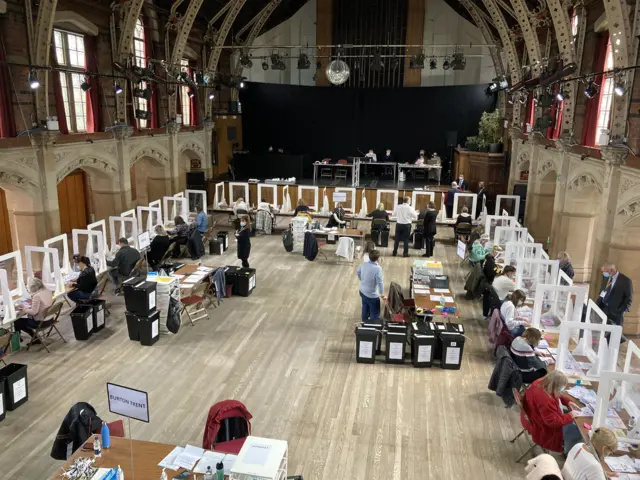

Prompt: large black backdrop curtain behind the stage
[{"left": 240, "top": 83, "right": 496, "bottom": 169}]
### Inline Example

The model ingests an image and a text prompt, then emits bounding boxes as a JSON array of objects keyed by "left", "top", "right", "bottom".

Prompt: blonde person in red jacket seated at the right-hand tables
[{"left": 524, "top": 371, "right": 582, "bottom": 453}]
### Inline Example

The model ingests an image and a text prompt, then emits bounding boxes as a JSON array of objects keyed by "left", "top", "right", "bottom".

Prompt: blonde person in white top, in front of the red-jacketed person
[{"left": 562, "top": 427, "right": 618, "bottom": 480}]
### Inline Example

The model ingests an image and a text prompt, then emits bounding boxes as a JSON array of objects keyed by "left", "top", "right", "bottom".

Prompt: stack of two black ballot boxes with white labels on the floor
[{"left": 122, "top": 276, "right": 160, "bottom": 346}]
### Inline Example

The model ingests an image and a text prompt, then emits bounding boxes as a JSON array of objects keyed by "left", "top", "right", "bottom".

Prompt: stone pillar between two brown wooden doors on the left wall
[{"left": 31, "top": 131, "right": 60, "bottom": 241}]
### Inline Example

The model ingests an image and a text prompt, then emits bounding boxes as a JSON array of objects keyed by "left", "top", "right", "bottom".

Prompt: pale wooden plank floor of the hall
[{"left": 0, "top": 225, "right": 528, "bottom": 480}]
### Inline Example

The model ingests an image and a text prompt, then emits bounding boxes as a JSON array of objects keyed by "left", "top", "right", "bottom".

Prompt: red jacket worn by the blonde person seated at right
[{"left": 524, "top": 379, "right": 573, "bottom": 452}]
